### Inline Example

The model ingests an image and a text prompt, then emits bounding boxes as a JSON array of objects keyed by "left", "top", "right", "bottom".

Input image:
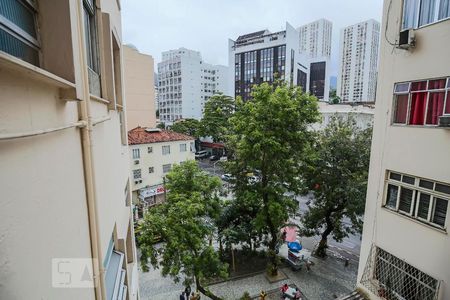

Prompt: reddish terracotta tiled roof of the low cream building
[{"left": 128, "top": 127, "right": 195, "bottom": 145}]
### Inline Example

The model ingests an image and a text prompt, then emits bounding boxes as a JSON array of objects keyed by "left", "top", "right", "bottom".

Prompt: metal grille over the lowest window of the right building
[{"left": 360, "top": 245, "right": 440, "bottom": 300}]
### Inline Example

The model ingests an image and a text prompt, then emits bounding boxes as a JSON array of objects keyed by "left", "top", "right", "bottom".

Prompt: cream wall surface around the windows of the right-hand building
[{"left": 358, "top": 0, "right": 450, "bottom": 299}]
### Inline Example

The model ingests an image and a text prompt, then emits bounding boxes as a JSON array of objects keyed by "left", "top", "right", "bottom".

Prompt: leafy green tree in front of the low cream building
[{"left": 139, "top": 161, "right": 228, "bottom": 300}]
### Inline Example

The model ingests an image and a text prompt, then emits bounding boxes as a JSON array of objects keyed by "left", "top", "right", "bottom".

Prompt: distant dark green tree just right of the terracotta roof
[{"left": 201, "top": 94, "right": 235, "bottom": 142}]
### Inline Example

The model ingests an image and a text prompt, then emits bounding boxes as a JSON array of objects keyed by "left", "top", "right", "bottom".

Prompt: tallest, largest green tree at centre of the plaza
[{"left": 228, "top": 82, "right": 318, "bottom": 274}]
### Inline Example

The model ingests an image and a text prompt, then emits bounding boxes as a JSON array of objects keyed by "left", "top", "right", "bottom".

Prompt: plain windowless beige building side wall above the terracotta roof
[{"left": 123, "top": 45, "right": 156, "bottom": 129}]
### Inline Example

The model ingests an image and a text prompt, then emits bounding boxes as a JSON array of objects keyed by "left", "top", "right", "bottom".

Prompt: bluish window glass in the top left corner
[{"left": 0, "top": 0, "right": 39, "bottom": 66}]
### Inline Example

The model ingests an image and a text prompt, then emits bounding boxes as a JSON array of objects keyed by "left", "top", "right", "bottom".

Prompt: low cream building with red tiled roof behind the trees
[{"left": 128, "top": 127, "right": 195, "bottom": 214}]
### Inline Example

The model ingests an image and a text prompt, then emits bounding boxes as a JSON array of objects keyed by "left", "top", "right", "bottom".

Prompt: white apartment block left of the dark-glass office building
[{"left": 158, "top": 48, "right": 231, "bottom": 124}]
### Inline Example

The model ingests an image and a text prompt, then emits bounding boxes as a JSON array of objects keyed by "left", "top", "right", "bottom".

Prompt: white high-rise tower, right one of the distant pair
[{"left": 337, "top": 20, "right": 380, "bottom": 102}]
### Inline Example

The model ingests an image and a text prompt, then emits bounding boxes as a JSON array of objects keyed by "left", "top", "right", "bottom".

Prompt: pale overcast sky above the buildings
[{"left": 121, "top": 0, "right": 383, "bottom": 75}]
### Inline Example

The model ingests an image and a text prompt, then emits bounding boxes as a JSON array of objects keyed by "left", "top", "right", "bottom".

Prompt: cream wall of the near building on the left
[{"left": 0, "top": 0, "right": 138, "bottom": 299}]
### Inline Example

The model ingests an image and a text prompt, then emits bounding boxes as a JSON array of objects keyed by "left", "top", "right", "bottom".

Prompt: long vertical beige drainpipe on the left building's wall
[{"left": 70, "top": 1, "right": 106, "bottom": 300}]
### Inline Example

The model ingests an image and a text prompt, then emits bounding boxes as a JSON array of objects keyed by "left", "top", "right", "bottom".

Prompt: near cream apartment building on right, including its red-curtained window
[{"left": 358, "top": 0, "right": 450, "bottom": 300}]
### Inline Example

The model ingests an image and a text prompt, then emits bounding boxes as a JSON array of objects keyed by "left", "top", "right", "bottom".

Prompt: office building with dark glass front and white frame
[{"left": 228, "top": 23, "right": 309, "bottom": 100}]
